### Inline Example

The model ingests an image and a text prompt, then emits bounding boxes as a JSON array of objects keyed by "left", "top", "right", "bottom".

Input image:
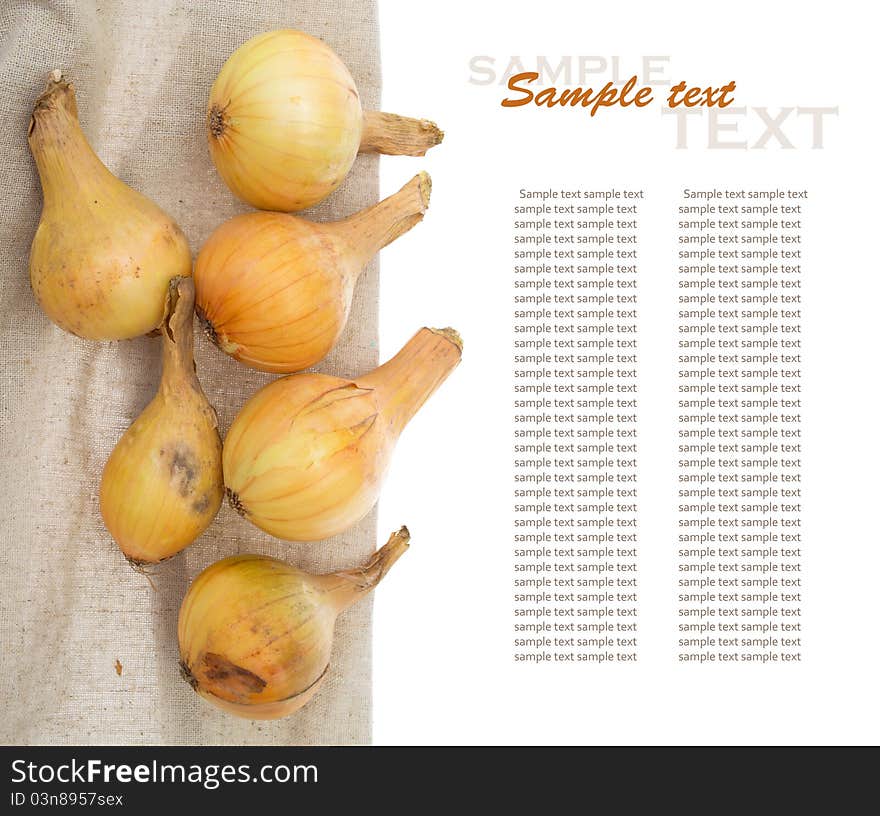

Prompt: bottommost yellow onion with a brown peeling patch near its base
[{"left": 177, "top": 527, "right": 409, "bottom": 720}]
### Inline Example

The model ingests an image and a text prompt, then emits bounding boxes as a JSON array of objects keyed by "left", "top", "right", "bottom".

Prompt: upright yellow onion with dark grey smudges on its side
[{"left": 100, "top": 278, "right": 223, "bottom": 565}]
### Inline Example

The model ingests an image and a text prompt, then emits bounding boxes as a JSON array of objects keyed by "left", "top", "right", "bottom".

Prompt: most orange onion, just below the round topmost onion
[{"left": 194, "top": 173, "right": 431, "bottom": 374}]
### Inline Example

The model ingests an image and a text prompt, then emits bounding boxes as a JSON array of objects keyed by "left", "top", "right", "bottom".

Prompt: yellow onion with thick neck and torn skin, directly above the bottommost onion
[{"left": 223, "top": 329, "right": 461, "bottom": 541}]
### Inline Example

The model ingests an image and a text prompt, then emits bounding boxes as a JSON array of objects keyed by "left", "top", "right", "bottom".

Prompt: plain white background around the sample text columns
[{"left": 374, "top": 0, "right": 880, "bottom": 744}]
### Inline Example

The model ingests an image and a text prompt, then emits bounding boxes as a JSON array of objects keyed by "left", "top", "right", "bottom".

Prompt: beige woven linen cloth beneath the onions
[{"left": 0, "top": 0, "right": 380, "bottom": 745}]
